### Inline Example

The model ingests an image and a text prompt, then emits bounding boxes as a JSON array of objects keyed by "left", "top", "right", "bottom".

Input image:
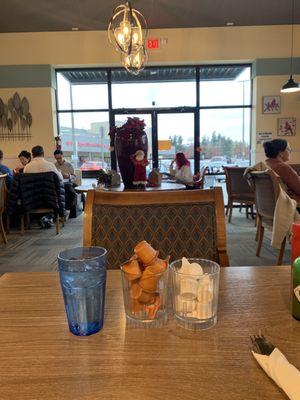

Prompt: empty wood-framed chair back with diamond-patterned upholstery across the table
[{"left": 83, "top": 188, "right": 228, "bottom": 268}]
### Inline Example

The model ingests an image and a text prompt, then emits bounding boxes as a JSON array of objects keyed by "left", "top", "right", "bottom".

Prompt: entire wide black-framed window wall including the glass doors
[{"left": 57, "top": 65, "right": 251, "bottom": 172}]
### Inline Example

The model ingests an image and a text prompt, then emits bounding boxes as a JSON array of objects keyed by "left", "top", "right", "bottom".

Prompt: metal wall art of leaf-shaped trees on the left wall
[{"left": 0, "top": 92, "right": 32, "bottom": 140}]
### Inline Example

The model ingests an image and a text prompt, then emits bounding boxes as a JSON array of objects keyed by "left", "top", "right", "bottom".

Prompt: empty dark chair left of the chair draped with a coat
[{"left": 223, "top": 166, "right": 254, "bottom": 222}]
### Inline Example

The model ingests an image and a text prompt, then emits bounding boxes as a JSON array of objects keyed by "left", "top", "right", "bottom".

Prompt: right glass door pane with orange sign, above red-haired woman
[{"left": 157, "top": 112, "right": 195, "bottom": 172}]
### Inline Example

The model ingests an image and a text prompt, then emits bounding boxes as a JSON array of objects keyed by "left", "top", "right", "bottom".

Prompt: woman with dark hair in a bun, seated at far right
[{"left": 264, "top": 139, "right": 300, "bottom": 202}]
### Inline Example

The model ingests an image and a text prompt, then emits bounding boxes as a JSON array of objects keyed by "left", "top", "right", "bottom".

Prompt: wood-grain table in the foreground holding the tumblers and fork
[{"left": 0, "top": 266, "right": 300, "bottom": 400}]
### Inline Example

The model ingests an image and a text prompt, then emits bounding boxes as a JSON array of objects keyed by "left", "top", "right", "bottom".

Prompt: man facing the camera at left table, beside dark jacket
[{"left": 53, "top": 150, "right": 77, "bottom": 210}]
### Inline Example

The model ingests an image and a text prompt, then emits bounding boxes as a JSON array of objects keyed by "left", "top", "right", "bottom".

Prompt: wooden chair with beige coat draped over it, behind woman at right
[{"left": 249, "top": 169, "right": 286, "bottom": 265}]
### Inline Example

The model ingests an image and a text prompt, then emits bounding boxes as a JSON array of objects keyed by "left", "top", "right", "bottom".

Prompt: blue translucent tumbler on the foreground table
[{"left": 58, "top": 247, "right": 107, "bottom": 336}]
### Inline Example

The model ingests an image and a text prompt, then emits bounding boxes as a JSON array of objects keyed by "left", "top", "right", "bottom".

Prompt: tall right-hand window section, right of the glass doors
[{"left": 199, "top": 66, "right": 251, "bottom": 172}]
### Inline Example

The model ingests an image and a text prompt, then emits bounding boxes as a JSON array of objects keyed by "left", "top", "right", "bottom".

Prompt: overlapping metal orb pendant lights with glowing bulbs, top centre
[{"left": 107, "top": 1, "right": 148, "bottom": 75}]
